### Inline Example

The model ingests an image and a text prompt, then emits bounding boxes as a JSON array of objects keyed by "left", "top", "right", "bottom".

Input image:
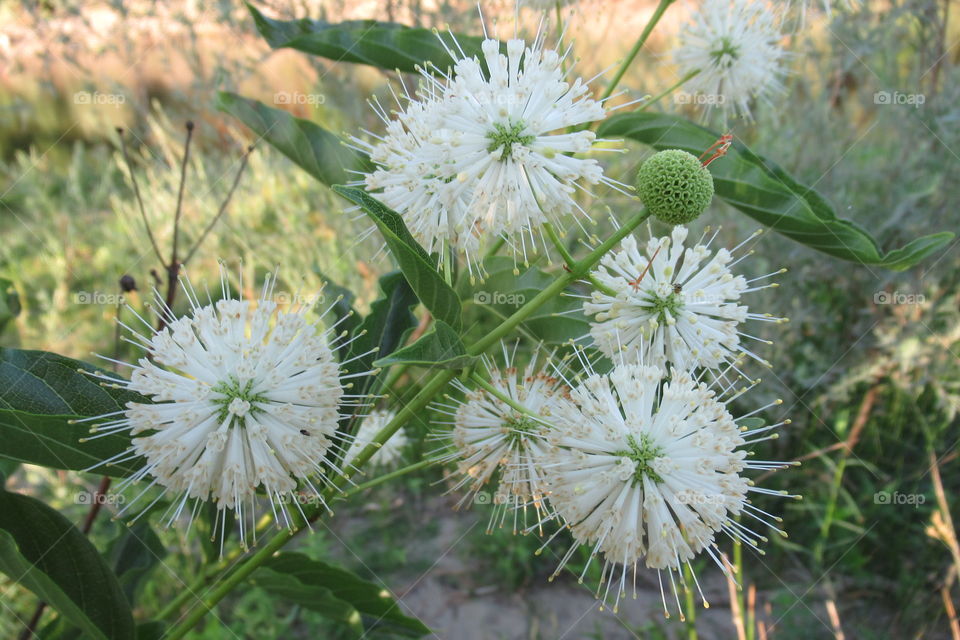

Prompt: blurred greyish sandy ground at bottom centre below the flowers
[{"left": 332, "top": 496, "right": 760, "bottom": 640}]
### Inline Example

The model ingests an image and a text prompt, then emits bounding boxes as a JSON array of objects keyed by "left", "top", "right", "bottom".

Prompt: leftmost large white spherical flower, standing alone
[{"left": 78, "top": 273, "right": 372, "bottom": 552}]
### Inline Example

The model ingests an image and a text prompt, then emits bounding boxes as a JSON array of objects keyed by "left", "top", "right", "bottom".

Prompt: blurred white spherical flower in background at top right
[{"left": 673, "top": 0, "right": 787, "bottom": 117}]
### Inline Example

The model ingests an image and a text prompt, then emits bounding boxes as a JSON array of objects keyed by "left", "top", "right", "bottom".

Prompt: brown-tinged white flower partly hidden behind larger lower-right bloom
[{"left": 438, "top": 346, "right": 567, "bottom": 533}]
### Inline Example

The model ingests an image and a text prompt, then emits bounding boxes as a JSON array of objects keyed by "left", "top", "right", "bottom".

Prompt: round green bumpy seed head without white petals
[{"left": 637, "top": 149, "right": 713, "bottom": 224}]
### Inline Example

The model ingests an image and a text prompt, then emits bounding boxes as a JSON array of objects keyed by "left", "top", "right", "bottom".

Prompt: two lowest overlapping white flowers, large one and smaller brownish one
[{"left": 445, "top": 344, "right": 789, "bottom": 612}]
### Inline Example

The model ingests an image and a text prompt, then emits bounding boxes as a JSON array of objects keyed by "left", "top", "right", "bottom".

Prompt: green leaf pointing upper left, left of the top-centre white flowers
[{"left": 217, "top": 91, "right": 372, "bottom": 185}]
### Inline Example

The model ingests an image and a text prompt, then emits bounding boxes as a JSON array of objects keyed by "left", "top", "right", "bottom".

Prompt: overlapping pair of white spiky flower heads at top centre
[{"left": 354, "top": 37, "right": 609, "bottom": 270}]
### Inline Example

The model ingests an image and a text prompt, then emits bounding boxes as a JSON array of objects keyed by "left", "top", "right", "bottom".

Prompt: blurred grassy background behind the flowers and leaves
[{"left": 0, "top": 0, "right": 960, "bottom": 640}]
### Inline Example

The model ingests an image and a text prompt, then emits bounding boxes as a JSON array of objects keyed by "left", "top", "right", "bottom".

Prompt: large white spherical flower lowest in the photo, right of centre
[{"left": 544, "top": 365, "right": 785, "bottom": 611}]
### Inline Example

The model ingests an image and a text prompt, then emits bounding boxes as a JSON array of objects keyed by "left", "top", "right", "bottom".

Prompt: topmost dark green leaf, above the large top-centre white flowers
[{"left": 247, "top": 4, "right": 483, "bottom": 72}]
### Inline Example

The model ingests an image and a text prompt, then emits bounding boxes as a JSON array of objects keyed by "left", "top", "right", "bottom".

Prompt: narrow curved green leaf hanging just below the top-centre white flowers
[{"left": 333, "top": 185, "right": 462, "bottom": 331}]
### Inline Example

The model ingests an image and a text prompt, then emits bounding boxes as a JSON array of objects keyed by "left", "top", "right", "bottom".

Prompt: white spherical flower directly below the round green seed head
[{"left": 583, "top": 226, "right": 783, "bottom": 369}]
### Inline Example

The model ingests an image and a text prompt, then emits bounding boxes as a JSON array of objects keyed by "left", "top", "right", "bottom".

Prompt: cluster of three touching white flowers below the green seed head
[{"left": 446, "top": 226, "right": 789, "bottom": 615}]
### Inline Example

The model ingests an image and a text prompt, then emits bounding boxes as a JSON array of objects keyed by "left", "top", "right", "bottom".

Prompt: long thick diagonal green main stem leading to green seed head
[{"left": 165, "top": 209, "right": 652, "bottom": 640}]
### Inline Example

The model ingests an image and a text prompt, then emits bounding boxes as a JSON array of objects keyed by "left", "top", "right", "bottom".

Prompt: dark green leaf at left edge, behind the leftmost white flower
[{"left": 0, "top": 348, "right": 150, "bottom": 476}]
